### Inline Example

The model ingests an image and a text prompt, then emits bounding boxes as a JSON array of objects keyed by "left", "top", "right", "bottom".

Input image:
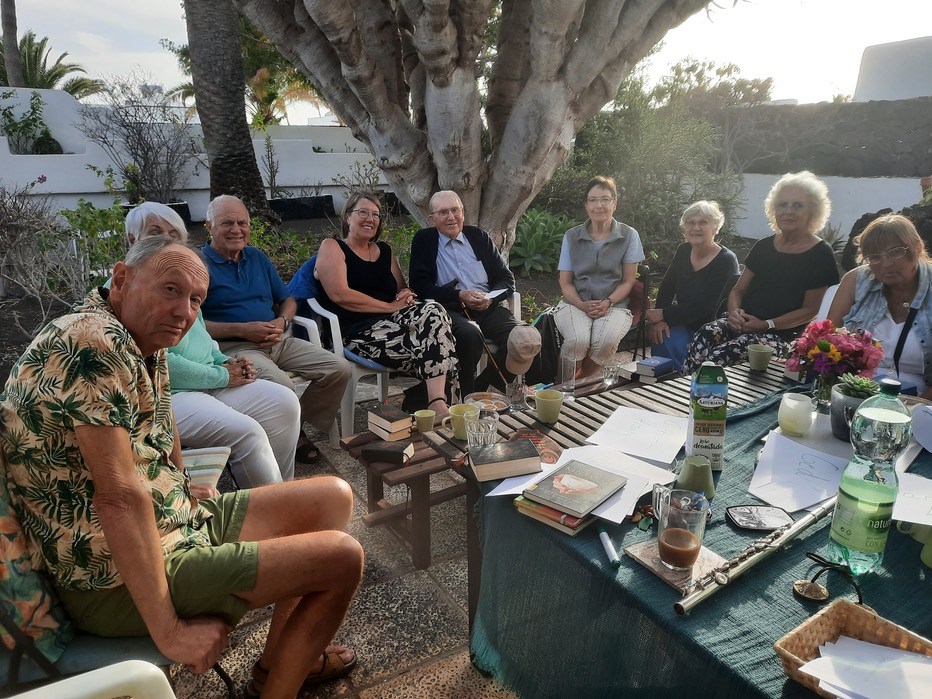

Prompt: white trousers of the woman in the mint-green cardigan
[{"left": 172, "top": 379, "right": 301, "bottom": 488}]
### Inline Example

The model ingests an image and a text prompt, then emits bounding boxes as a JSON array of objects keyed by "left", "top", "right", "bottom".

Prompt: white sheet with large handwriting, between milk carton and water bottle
[{"left": 748, "top": 432, "right": 848, "bottom": 512}]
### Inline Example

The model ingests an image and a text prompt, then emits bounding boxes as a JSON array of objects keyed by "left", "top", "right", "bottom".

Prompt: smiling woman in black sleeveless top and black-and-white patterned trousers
[{"left": 314, "top": 192, "right": 458, "bottom": 416}]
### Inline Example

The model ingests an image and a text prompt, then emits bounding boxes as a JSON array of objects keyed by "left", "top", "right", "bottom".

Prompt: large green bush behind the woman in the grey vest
[{"left": 534, "top": 62, "right": 740, "bottom": 273}]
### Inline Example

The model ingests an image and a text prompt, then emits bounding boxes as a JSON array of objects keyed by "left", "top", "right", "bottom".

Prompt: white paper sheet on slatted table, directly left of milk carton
[{"left": 586, "top": 407, "right": 688, "bottom": 463}]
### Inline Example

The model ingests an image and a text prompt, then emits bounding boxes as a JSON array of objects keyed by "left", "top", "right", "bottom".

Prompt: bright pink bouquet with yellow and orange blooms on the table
[{"left": 786, "top": 320, "right": 883, "bottom": 378}]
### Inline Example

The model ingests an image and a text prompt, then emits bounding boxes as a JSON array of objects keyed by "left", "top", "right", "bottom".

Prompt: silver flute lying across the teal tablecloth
[{"left": 673, "top": 496, "right": 837, "bottom": 614}]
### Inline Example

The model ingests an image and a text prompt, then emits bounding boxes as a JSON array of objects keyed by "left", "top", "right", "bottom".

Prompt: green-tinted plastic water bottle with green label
[{"left": 828, "top": 378, "right": 912, "bottom": 575}]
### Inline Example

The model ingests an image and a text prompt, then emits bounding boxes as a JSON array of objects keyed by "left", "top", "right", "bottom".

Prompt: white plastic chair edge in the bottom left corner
[{"left": 10, "top": 660, "right": 175, "bottom": 699}]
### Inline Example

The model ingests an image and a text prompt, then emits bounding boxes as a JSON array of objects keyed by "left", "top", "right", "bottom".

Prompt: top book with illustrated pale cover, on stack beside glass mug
[{"left": 522, "top": 459, "right": 628, "bottom": 517}]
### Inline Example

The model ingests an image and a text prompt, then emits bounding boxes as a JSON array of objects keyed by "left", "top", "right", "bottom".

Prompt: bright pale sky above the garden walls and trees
[{"left": 16, "top": 0, "right": 932, "bottom": 123}]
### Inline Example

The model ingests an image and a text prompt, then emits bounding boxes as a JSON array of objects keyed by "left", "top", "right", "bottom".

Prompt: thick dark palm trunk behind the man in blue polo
[{"left": 184, "top": 0, "right": 279, "bottom": 223}]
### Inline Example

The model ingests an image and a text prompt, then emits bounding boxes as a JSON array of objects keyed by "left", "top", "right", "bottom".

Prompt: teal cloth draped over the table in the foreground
[{"left": 472, "top": 395, "right": 932, "bottom": 699}]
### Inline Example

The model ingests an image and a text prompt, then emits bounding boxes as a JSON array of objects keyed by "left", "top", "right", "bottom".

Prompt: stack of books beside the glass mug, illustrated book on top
[{"left": 515, "top": 459, "right": 628, "bottom": 536}]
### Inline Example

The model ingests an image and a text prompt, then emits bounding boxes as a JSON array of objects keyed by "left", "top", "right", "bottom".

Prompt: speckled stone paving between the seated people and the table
[{"left": 174, "top": 379, "right": 517, "bottom": 699}]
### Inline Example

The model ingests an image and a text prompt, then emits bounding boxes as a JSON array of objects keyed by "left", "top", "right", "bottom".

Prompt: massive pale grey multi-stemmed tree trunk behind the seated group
[{"left": 234, "top": 0, "right": 709, "bottom": 251}]
